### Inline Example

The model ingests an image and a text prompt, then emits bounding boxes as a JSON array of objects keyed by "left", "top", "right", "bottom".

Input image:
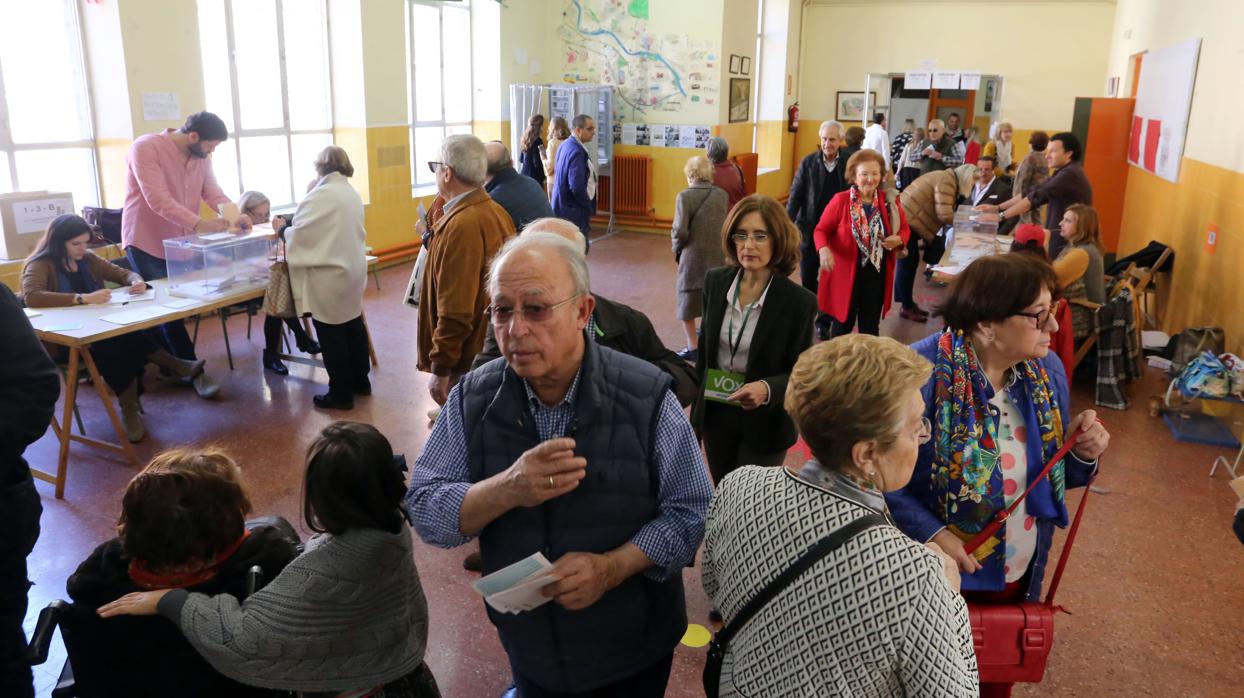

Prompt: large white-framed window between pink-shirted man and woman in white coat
[{"left": 199, "top": 0, "right": 332, "bottom": 207}]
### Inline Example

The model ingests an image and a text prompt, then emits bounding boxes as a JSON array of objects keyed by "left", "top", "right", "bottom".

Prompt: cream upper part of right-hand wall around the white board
[{"left": 1107, "top": 0, "right": 1244, "bottom": 172}]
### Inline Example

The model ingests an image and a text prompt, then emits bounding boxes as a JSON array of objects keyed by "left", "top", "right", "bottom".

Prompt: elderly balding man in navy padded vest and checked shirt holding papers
[{"left": 406, "top": 233, "right": 713, "bottom": 698}]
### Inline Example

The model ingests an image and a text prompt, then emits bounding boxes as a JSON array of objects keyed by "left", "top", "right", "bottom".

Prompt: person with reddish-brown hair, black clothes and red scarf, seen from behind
[{"left": 66, "top": 449, "right": 297, "bottom": 698}]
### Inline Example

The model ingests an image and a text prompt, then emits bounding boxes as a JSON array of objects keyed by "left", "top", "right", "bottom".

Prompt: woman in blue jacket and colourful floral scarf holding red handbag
[{"left": 886, "top": 255, "right": 1110, "bottom": 696}]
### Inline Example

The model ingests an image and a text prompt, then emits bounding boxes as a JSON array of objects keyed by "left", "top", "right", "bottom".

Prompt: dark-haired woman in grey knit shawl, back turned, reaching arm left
[{"left": 98, "top": 422, "right": 440, "bottom": 698}]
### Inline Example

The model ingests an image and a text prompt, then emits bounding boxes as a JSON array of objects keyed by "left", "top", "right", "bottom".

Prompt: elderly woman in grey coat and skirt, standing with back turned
[{"left": 669, "top": 156, "right": 729, "bottom": 361}]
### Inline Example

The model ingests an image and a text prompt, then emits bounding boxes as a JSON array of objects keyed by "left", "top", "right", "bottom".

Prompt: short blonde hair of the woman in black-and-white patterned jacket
[{"left": 785, "top": 335, "right": 933, "bottom": 470}]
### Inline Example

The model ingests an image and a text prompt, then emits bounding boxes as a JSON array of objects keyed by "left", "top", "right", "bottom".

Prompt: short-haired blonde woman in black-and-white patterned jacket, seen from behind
[{"left": 702, "top": 335, "right": 978, "bottom": 697}]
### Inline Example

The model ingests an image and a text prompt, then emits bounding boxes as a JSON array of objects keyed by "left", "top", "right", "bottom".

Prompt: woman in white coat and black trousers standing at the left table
[{"left": 272, "top": 146, "right": 372, "bottom": 409}]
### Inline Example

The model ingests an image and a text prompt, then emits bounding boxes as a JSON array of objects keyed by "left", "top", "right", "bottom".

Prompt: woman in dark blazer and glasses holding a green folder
[{"left": 692, "top": 194, "right": 816, "bottom": 483}]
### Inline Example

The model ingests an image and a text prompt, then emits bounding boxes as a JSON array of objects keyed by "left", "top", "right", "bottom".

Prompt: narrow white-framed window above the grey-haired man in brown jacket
[{"left": 406, "top": 0, "right": 473, "bottom": 192}]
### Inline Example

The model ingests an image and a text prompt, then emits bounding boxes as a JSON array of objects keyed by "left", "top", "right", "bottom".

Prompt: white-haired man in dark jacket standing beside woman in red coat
[{"left": 786, "top": 121, "right": 851, "bottom": 338}]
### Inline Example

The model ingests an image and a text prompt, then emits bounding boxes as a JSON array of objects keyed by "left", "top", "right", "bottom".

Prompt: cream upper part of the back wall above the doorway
[{"left": 799, "top": 0, "right": 1114, "bottom": 128}]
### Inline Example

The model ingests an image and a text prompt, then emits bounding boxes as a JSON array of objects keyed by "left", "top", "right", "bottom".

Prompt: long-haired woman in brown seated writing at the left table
[{"left": 21, "top": 214, "right": 204, "bottom": 442}]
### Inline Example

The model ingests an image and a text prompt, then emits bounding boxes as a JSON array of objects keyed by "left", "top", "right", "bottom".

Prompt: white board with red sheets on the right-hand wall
[{"left": 1127, "top": 39, "right": 1200, "bottom": 182}]
